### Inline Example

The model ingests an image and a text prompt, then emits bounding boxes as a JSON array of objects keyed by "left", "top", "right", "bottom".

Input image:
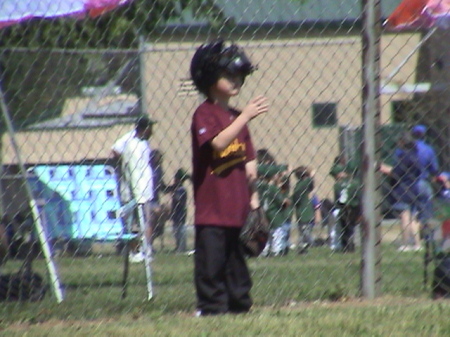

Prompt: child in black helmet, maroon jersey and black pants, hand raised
[{"left": 190, "top": 40, "right": 269, "bottom": 316}]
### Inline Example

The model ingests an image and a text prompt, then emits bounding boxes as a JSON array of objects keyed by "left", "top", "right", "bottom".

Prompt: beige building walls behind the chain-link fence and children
[{"left": 3, "top": 34, "right": 420, "bottom": 213}]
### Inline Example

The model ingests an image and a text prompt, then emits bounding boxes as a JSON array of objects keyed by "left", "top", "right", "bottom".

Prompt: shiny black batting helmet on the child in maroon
[{"left": 190, "top": 39, "right": 256, "bottom": 95}]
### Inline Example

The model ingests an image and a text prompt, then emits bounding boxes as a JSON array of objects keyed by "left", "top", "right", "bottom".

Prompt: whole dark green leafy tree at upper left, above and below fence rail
[{"left": 0, "top": 0, "right": 232, "bottom": 132}]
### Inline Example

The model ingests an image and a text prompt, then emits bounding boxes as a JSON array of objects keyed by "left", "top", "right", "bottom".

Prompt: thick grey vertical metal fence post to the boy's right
[{"left": 361, "top": 0, "right": 381, "bottom": 299}]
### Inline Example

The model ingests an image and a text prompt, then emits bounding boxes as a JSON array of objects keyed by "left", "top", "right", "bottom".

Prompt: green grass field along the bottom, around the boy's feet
[{"left": 0, "top": 234, "right": 450, "bottom": 336}]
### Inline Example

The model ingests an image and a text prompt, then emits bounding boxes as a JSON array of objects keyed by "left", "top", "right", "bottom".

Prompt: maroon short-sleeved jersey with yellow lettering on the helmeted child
[{"left": 191, "top": 101, "right": 255, "bottom": 227}]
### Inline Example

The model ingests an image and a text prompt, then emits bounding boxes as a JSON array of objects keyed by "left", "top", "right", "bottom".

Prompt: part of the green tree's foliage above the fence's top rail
[{"left": 0, "top": 0, "right": 230, "bottom": 48}]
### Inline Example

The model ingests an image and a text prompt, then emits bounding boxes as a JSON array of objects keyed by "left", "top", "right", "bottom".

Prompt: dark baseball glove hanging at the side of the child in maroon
[{"left": 239, "top": 207, "right": 269, "bottom": 257}]
